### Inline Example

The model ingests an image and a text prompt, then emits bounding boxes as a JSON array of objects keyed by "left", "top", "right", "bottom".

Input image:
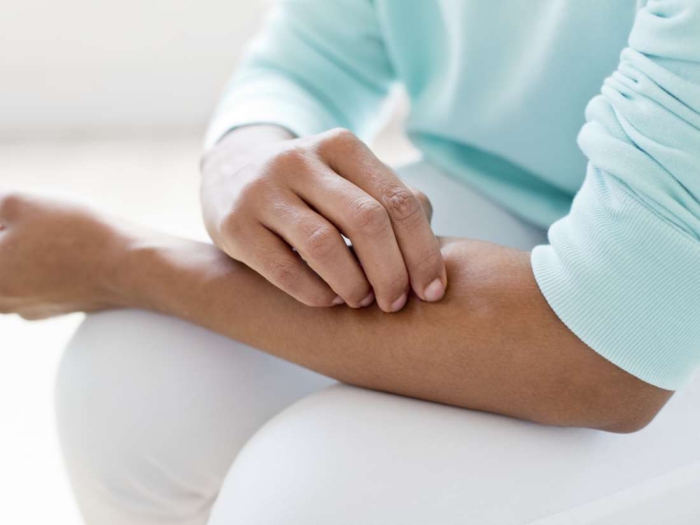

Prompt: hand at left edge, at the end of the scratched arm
[{"left": 0, "top": 191, "right": 128, "bottom": 319}]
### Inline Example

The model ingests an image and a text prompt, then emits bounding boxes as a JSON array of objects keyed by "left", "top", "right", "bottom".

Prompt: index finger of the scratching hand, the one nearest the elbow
[{"left": 319, "top": 132, "right": 447, "bottom": 301}]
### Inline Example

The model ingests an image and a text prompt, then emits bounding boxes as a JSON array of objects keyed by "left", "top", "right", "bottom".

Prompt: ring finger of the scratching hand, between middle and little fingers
[{"left": 265, "top": 195, "right": 373, "bottom": 308}]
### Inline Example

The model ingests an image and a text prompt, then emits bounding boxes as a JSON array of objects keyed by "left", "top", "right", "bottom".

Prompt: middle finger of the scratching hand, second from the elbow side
[{"left": 297, "top": 170, "right": 409, "bottom": 312}]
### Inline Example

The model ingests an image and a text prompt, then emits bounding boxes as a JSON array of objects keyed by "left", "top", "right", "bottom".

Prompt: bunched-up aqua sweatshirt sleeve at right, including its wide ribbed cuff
[{"left": 531, "top": 0, "right": 700, "bottom": 390}]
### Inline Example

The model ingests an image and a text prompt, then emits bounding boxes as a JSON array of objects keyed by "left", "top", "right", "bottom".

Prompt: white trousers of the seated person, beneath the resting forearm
[{"left": 56, "top": 164, "right": 700, "bottom": 525}]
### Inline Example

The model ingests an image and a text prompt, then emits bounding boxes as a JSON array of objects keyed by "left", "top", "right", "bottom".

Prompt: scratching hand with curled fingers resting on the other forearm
[{"left": 202, "top": 126, "right": 447, "bottom": 312}]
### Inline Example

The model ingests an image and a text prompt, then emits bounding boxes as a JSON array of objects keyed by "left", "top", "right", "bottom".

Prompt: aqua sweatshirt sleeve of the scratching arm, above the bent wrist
[{"left": 205, "top": 0, "right": 394, "bottom": 149}]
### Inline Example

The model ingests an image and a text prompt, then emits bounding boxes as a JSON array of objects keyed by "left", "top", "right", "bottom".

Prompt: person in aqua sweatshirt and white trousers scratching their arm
[{"left": 0, "top": 0, "right": 700, "bottom": 525}]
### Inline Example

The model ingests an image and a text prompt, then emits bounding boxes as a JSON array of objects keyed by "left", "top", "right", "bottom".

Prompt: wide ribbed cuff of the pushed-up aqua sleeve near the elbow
[{"left": 531, "top": 167, "right": 700, "bottom": 390}]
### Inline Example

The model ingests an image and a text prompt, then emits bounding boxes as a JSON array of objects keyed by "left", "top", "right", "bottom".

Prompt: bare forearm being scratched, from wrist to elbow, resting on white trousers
[{"left": 125, "top": 235, "right": 671, "bottom": 432}]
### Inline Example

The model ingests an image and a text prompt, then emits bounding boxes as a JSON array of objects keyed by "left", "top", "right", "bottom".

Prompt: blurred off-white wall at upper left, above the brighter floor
[{"left": 0, "top": 0, "right": 270, "bottom": 139}]
